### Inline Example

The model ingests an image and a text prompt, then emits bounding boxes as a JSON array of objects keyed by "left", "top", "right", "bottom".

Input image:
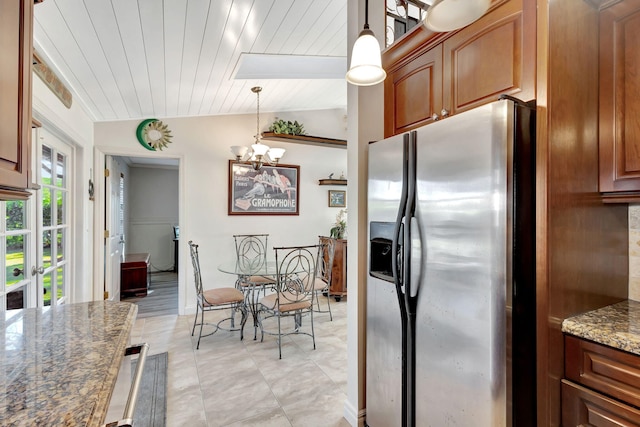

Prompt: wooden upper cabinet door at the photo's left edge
[{"left": 0, "top": 0, "right": 33, "bottom": 199}]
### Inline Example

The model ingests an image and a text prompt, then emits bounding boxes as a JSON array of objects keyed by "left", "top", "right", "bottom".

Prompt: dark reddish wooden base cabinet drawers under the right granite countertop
[{"left": 562, "top": 335, "right": 640, "bottom": 427}]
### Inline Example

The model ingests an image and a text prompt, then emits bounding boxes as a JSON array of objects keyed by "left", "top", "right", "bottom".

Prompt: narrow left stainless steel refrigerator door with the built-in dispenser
[{"left": 366, "top": 135, "right": 403, "bottom": 427}]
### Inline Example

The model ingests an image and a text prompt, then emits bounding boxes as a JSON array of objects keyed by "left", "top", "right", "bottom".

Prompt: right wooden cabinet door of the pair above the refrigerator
[{"left": 443, "top": 0, "right": 536, "bottom": 114}]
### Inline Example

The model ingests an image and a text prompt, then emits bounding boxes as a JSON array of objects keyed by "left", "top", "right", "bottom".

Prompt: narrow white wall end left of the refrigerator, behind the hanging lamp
[{"left": 344, "top": 0, "right": 385, "bottom": 426}]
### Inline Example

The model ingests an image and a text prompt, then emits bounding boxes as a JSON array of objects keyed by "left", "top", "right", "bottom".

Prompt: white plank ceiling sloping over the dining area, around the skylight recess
[{"left": 34, "top": 0, "right": 347, "bottom": 121}]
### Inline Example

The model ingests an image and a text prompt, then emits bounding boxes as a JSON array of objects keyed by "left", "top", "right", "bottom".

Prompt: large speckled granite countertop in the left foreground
[{"left": 0, "top": 301, "right": 138, "bottom": 426}]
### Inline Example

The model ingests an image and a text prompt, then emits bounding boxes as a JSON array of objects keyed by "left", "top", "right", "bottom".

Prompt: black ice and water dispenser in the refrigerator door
[{"left": 369, "top": 221, "right": 403, "bottom": 283}]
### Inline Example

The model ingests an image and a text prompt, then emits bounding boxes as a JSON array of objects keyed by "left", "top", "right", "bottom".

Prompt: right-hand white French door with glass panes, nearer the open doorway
[{"left": 34, "top": 132, "right": 72, "bottom": 306}]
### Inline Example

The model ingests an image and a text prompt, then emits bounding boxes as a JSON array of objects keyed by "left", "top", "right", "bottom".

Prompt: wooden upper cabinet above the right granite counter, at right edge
[{"left": 599, "top": 0, "right": 640, "bottom": 198}]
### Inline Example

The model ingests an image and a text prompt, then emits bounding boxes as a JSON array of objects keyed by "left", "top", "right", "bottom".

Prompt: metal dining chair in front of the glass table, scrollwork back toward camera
[{"left": 258, "top": 245, "right": 321, "bottom": 359}]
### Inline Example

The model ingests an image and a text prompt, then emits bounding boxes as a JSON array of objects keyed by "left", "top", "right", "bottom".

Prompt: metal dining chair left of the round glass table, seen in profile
[{"left": 189, "top": 240, "right": 247, "bottom": 349}]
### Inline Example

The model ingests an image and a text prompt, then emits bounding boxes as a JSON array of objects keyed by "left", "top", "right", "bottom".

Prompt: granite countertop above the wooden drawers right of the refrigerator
[{"left": 562, "top": 301, "right": 640, "bottom": 356}]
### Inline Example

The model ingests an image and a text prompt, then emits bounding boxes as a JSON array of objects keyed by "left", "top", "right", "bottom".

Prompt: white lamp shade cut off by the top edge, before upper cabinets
[{"left": 424, "top": 0, "right": 491, "bottom": 33}]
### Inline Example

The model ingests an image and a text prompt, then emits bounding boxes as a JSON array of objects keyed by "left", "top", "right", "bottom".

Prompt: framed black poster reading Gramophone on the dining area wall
[{"left": 228, "top": 160, "right": 300, "bottom": 215}]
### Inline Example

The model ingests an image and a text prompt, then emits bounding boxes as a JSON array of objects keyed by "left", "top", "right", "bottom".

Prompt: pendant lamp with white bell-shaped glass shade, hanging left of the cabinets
[{"left": 346, "top": 0, "right": 387, "bottom": 86}]
